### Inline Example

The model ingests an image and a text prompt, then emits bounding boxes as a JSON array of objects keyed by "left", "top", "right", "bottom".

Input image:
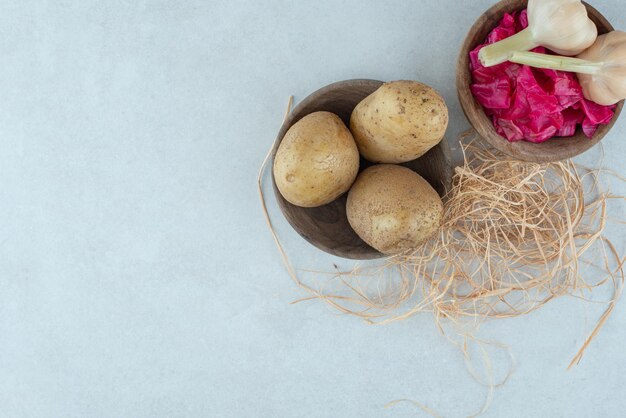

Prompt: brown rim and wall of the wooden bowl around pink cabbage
[{"left": 456, "top": 0, "right": 624, "bottom": 163}]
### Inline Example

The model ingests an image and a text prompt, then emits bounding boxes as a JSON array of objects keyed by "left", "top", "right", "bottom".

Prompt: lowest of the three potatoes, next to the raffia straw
[{"left": 346, "top": 164, "right": 443, "bottom": 255}]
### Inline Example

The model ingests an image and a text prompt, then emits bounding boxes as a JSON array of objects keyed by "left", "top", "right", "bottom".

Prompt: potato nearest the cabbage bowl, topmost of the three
[{"left": 350, "top": 81, "right": 448, "bottom": 163}]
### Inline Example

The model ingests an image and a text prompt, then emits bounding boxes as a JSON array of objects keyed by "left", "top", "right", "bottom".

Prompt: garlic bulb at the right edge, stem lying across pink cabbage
[{"left": 510, "top": 31, "right": 626, "bottom": 106}]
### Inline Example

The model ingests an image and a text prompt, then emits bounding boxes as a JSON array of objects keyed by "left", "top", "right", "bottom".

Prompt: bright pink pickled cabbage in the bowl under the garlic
[{"left": 470, "top": 10, "right": 615, "bottom": 143}]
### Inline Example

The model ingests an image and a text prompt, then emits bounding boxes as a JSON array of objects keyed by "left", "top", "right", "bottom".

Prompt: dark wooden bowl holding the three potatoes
[{"left": 272, "top": 80, "right": 452, "bottom": 260}]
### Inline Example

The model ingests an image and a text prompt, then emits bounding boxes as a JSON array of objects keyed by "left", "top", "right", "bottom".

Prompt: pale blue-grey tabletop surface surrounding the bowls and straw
[{"left": 0, "top": 0, "right": 626, "bottom": 417}]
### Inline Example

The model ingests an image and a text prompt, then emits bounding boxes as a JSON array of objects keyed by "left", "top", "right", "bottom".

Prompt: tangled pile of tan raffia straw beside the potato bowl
[{"left": 259, "top": 121, "right": 625, "bottom": 367}]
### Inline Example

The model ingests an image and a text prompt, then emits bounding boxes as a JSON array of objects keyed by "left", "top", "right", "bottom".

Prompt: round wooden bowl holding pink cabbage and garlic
[{"left": 456, "top": 0, "right": 624, "bottom": 162}]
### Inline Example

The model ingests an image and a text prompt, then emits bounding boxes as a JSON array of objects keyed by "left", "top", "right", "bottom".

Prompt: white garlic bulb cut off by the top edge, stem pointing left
[{"left": 478, "top": 0, "right": 598, "bottom": 67}]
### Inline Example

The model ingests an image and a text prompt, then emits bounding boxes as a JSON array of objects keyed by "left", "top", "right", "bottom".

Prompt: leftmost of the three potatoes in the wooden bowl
[{"left": 274, "top": 112, "right": 359, "bottom": 208}]
